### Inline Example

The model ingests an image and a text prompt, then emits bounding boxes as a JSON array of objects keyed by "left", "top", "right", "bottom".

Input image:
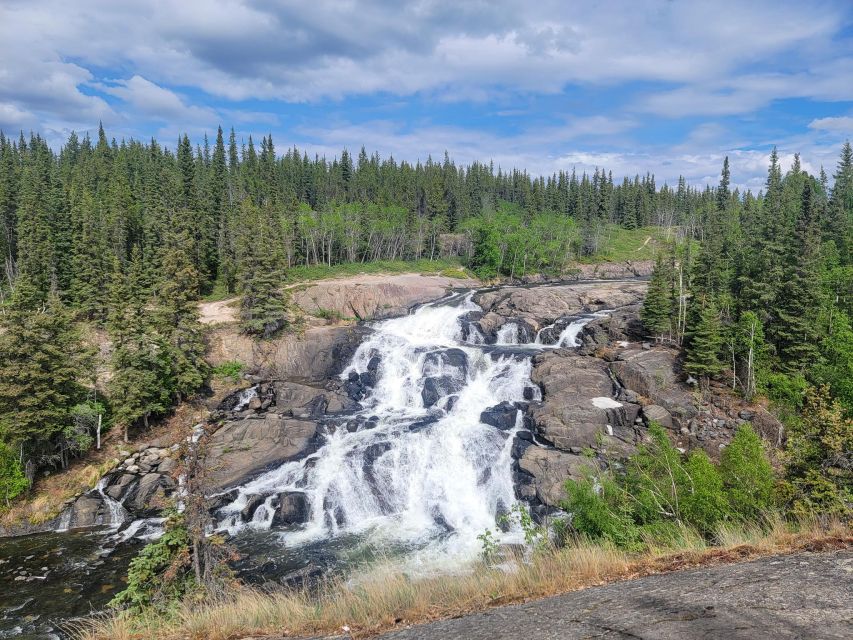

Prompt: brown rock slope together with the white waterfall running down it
[{"left": 0, "top": 272, "right": 778, "bottom": 636}]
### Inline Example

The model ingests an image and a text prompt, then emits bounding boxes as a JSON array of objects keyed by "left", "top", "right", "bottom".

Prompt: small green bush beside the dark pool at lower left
[{"left": 110, "top": 511, "right": 194, "bottom": 612}]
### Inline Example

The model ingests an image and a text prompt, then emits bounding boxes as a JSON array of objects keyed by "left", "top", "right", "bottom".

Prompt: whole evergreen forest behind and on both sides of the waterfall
[{"left": 0, "top": 129, "right": 853, "bottom": 516}]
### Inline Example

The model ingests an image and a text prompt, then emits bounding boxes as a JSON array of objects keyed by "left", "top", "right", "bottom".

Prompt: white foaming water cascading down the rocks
[{"left": 220, "top": 293, "right": 608, "bottom": 565}]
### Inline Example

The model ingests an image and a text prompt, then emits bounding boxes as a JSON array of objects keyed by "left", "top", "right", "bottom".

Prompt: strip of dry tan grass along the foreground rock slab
[{"left": 78, "top": 518, "right": 853, "bottom": 640}]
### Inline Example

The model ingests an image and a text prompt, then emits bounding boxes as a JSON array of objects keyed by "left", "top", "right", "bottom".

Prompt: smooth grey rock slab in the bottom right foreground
[{"left": 374, "top": 550, "right": 853, "bottom": 640}]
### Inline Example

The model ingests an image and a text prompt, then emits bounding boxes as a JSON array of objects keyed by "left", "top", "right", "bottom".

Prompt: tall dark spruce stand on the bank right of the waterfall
[{"left": 641, "top": 149, "right": 853, "bottom": 517}]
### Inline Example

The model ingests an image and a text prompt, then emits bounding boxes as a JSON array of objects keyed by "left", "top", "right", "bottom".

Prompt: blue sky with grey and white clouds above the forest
[{"left": 0, "top": 0, "right": 853, "bottom": 191}]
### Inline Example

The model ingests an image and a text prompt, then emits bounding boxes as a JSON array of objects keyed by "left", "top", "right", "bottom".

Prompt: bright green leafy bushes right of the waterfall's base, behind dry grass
[{"left": 561, "top": 424, "right": 784, "bottom": 549}]
